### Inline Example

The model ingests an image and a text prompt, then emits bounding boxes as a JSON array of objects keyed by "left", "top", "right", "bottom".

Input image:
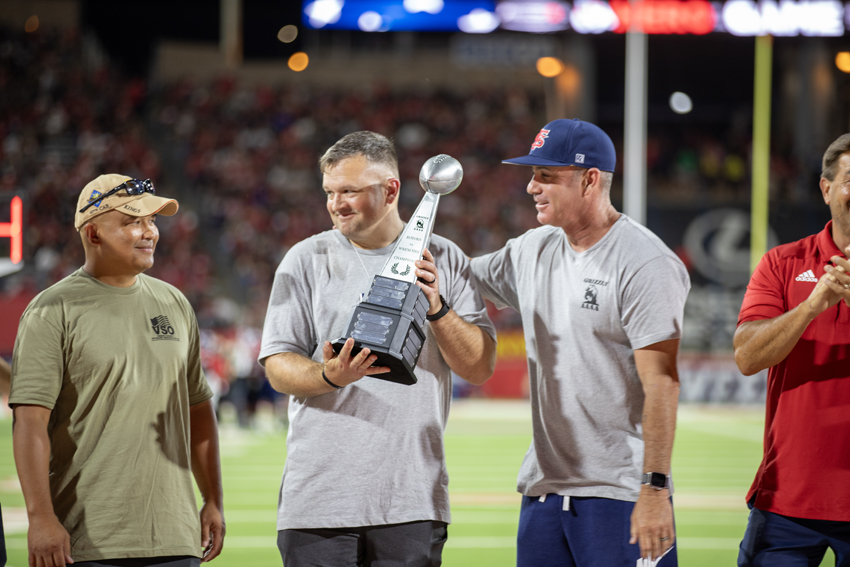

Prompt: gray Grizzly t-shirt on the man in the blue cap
[{"left": 471, "top": 215, "right": 690, "bottom": 501}]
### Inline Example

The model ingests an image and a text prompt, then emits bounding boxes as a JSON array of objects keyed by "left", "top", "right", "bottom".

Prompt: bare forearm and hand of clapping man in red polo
[{"left": 733, "top": 266, "right": 850, "bottom": 376}]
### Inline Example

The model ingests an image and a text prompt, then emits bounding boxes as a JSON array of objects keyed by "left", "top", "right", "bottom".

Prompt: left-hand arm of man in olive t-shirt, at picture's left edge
[{"left": 12, "top": 405, "right": 74, "bottom": 567}]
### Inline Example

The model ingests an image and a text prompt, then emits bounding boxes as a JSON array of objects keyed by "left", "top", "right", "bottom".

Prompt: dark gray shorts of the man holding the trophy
[{"left": 277, "top": 521, "right": 448, "bottom": 567}]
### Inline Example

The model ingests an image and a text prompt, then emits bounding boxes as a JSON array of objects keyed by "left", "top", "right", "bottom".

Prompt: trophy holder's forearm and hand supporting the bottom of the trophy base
[{"left": 265, "top": 338, "right": 390, "bottom": 398}]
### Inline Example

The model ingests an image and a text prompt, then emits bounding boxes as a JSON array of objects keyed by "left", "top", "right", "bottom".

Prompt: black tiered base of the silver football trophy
[{"left": 333, "top": 276, "right": 428, "bottom": 385}]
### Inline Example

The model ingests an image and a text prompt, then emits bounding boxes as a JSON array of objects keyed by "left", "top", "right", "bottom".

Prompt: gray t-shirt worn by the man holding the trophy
[{"left": 260, "top": 230, "right": 496, "bottom": 530}]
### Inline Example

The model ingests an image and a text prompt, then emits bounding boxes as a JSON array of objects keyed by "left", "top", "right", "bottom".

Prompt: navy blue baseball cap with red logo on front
[{"left": 502, "top": 118, "right": 617, "bottom": 172}]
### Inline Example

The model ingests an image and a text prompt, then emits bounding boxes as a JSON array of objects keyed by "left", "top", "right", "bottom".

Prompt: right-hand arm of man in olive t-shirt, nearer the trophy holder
[{"left": 189, "top": 400, "right": 225, "bottom": 562}]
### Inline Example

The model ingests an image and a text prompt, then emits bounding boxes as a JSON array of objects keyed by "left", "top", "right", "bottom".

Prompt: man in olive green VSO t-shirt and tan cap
[{"left": 9, "top": 174, "right": 225, "bottom": 567}]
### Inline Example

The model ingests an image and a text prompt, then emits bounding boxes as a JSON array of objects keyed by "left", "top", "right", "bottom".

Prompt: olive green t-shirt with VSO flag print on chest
[{"left": 9, "top": 269, "right": 212, "bottom": 561}]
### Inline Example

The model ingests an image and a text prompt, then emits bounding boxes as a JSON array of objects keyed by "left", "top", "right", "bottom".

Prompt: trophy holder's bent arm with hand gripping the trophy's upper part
[{"left": 416, "top": 250, "right": 496, "bottom": 385}]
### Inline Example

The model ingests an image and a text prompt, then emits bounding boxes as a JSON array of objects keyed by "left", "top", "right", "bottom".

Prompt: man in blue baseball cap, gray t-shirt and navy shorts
[{"left": 471, "top": 119, "right": 690, "bottom": 567}]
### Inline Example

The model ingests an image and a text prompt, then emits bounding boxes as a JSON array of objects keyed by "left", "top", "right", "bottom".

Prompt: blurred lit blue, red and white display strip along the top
[{"left": 303, "top": 0, "right": 848, "bottom": 37}]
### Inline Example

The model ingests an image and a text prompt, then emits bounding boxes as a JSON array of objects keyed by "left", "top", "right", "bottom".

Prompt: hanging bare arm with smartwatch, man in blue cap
[{"left": 629, "top": 339, "right": 679, "bottom": 558}]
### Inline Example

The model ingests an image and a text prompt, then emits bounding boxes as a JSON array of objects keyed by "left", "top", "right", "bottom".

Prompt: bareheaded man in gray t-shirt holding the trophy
[{"left": 260, "top": 132, "right": 496, "bottom": 567}]
